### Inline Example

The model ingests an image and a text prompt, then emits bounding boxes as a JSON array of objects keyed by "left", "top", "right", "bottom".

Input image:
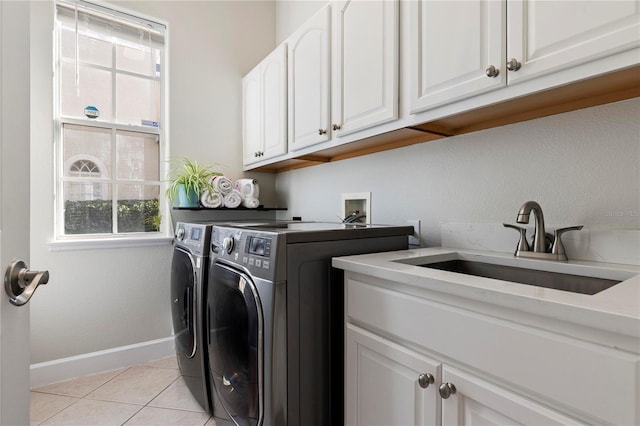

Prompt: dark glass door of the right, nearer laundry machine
[{"left": 207, "top": 263, "right": 264, "bottom": 426}]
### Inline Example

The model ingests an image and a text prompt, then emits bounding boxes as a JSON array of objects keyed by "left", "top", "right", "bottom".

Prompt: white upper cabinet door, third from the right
[{"left": 331, "top": 0, "right": 399, "bottom": 136}]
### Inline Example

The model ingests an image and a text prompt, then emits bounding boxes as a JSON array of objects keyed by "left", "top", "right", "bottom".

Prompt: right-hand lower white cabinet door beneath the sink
[{"left": 442, "top": 366, "right": 580, "bottom": 426}]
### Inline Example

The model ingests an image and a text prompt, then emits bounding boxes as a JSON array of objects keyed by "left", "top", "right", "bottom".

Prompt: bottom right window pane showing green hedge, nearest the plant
[{"left": 118, "top": 185, "right": 160, "bottom": 232}]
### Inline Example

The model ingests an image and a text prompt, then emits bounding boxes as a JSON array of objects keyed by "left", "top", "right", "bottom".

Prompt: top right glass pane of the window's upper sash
[{"left": 116, "top": 39, "right": 160, "bottom": 77}]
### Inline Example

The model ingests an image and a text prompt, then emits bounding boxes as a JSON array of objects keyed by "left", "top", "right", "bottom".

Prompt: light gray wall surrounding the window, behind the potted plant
[{"left": 30, "top": 1, "right": 275, "bottom": 363}]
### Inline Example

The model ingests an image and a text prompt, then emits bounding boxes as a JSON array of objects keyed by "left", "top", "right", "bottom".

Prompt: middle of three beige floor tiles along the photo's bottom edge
[{"left": 42, "top": 399, "right": 142, "bottom": 426}]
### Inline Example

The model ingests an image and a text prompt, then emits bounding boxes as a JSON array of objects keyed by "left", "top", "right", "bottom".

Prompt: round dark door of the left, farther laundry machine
[{"left": 171, "top": 247, "right": 197, "bottom": 358}]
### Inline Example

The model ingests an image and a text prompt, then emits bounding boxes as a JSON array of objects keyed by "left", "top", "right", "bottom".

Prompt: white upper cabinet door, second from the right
[{"left": 409, "top": 0, "right": 506, "bottom": 113}]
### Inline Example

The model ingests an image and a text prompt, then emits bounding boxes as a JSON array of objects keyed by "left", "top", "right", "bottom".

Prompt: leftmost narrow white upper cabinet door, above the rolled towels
[{"left": 242, "top": 65, "right": 262, "bottom": 164}]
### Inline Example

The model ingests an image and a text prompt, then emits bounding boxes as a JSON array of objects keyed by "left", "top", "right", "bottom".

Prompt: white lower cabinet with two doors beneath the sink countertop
[{"left": 345, "top": 271, "right": 640, "bottom": 426}]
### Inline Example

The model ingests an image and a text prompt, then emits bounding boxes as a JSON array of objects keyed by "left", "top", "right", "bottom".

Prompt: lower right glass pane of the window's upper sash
[{"left": 116, "top": 74, "right": 160, "bottom": 126}]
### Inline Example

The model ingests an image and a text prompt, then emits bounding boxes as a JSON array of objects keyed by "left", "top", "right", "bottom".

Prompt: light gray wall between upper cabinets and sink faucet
[{"left": 276, "top": 98, "right": 640, "bottom": 246}]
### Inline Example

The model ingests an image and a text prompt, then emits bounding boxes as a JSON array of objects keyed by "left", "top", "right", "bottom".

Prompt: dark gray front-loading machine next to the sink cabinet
[{"left": 206, "top": 222, "right": 413, "bottom": 426}]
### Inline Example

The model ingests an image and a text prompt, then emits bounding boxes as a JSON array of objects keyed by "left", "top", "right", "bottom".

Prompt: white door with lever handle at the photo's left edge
[{"left": 0, "top": 1, "right": 31, "bottom": 425}]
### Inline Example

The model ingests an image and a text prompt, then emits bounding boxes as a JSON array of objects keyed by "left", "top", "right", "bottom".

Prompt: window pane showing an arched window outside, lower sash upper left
[{"left": 62, "top": 124, "right": 112, "bottom": 179}]
